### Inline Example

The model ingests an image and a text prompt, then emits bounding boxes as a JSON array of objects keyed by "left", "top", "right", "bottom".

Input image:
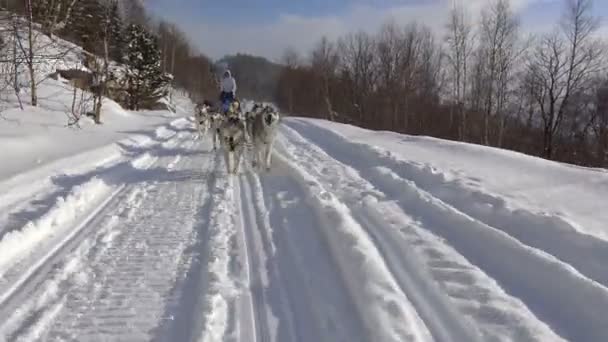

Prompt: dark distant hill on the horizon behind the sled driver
[{"left": 215, "top": 53, "right": 282, "bottom": 101}]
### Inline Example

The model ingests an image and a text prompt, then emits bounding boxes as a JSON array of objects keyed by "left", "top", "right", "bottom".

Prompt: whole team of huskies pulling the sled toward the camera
[{"left": 194, "top": 100, "right": 281, "bottom": 174}]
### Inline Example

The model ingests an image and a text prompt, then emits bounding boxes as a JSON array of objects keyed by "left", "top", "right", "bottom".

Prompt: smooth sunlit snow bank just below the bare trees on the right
[{"left": 285, "top": 118, "right": 608, "bottom": 241}]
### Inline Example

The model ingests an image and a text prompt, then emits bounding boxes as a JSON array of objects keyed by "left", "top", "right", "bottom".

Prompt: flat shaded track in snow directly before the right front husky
[{"left": 255, "top": 160, "right": 366, "bottom": 342}]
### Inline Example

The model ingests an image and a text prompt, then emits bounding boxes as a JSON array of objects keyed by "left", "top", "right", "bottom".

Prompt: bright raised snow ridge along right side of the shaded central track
[{"left": 268, "top": 154, "right": 432, "bottom": 341}]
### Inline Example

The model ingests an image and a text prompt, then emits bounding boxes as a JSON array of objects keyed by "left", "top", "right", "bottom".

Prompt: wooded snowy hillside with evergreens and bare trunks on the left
[{"left": 0, "top": 0, "right": 217, "bottom": 118}]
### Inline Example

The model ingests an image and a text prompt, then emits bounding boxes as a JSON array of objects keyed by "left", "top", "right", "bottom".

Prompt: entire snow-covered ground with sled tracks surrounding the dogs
[{"left": 0, "top": 111, "right": 608, "bottom": 342}]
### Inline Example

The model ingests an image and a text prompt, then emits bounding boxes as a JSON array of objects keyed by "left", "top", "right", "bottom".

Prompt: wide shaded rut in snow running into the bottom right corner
[{"left": 286, "top": 121, "right": 608, "bottom": 341}]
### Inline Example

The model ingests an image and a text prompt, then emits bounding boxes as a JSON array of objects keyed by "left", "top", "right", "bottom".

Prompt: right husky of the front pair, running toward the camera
[{"left": 251, "top": 106, "right": 281, "bottom": 170}]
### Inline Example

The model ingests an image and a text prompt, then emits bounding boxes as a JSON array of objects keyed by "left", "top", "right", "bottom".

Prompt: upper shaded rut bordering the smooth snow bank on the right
[{"left": 290, "top": 121, "right": 608, "bottom": 287}]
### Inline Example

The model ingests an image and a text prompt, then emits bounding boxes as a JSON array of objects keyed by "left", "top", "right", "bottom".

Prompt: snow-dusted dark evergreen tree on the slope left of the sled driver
[{"left": 126, "top": 24, "right": 169, "bottom": 110}]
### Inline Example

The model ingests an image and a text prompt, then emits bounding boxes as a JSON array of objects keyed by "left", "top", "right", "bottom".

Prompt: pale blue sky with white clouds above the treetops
[{"left": 145, "top": 0, "right": 608, "bottom": 60}]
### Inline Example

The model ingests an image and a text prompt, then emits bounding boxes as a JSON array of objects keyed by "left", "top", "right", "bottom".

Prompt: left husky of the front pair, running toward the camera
[{"left": 219, "top": 115, "right": 246, "bottom": 174}]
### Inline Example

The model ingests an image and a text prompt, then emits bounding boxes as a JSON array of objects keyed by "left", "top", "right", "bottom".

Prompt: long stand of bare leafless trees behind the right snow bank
[{"left": 278, "top": 0, "right": 608, "bottom": 165}]
